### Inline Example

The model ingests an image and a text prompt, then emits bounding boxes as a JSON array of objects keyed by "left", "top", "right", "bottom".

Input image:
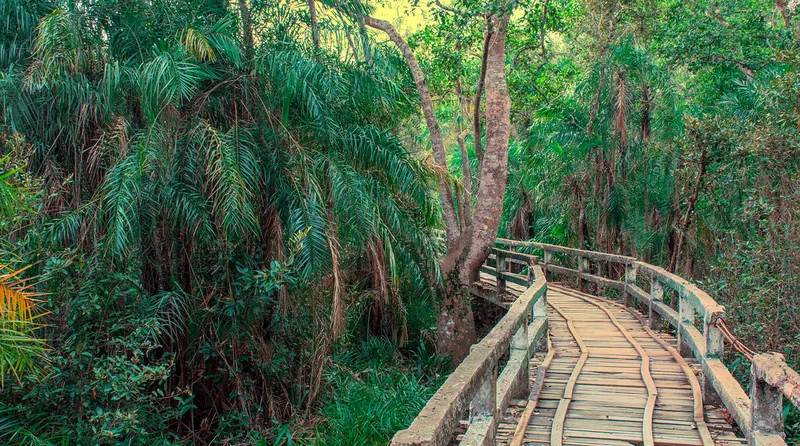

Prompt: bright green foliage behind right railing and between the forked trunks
[{"left": 414, "top": 0, "right": 800, "bottom": 436}]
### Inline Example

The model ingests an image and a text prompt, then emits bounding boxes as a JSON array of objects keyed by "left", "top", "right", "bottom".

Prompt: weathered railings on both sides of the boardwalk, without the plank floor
[{"left": 392, "top": 235, "right": 800, "bottom": 446}]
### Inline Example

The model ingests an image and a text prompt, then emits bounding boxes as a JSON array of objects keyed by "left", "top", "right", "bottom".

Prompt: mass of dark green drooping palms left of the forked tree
[{"left": 0, "top": 0, "right": 438, "bottom": 444}]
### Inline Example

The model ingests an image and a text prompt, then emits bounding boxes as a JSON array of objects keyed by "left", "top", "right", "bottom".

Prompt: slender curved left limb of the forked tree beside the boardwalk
[{"left": 362, "top": 16, "right": 461, "bottom": 244}]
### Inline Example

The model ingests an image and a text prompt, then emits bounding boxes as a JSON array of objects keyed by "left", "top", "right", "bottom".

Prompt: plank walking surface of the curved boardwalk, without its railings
[{"left": 497, "top": 285, "right": 746, "bottom": 446}]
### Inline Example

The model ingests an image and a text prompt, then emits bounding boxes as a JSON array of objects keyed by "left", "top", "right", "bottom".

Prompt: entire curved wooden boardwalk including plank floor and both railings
[{"left": 392, "top": 239, "right": 800, "bottom": 446}]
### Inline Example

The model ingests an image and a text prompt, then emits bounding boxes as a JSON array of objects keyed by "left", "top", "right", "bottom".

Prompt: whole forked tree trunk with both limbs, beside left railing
[{"left": 361, "top": 7, "right": 511, "bottom": 362}]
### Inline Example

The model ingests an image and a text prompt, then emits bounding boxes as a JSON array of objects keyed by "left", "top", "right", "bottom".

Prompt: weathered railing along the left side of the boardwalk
[{"left": 391, "top": 251, "right": 547, "bottom": 446}]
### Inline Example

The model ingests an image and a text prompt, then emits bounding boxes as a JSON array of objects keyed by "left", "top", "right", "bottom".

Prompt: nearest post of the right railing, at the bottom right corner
[{"left": 747, "top": 354, "right": 786, "bottom": 446}]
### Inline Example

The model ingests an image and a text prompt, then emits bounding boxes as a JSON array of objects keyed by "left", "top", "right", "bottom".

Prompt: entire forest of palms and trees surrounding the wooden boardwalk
[{"left": 0, "top": 0, "right": 800, "bottom": 445}]
